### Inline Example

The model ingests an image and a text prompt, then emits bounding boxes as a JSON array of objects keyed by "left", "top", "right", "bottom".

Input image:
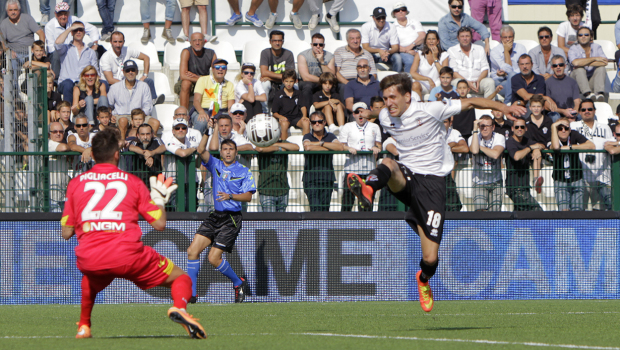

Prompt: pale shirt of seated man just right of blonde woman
[{"left": 108, "top": 79, "right": 153, "bottom": 116}]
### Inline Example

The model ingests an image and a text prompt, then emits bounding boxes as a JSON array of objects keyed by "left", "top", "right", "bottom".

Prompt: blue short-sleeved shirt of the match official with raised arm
[{"left": 202, "top": 156, "right": 256, "bottom": 211}]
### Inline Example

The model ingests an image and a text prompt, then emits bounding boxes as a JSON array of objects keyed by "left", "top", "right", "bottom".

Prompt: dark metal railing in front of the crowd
[{"left": 0, "top": 150, "right": 620, "bottom": 212}]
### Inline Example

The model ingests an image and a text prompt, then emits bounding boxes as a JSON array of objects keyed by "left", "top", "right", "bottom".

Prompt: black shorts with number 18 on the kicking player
[{"left": 390, "top": 163, "right": 446, "bottom": 244}]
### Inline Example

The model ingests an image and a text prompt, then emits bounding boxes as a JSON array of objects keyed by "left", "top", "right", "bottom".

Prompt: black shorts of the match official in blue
[{"left": 196, "top": 211, "right": 243, "bottom": 253}]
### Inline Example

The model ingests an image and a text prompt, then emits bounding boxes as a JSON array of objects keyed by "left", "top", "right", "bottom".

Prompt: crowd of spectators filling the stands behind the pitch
[{"left": 0, "top": 0, "right": 620, "bottom": 211}]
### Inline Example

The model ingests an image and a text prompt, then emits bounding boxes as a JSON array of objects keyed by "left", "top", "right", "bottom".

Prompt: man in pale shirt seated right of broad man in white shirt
[{"left": 491, "top": 26, "right": 527, "bottom": 101}]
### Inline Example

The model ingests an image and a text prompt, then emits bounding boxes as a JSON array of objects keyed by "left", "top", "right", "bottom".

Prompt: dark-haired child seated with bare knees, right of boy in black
[{"left": 312, "top": 72, "right": 346, "bottom": 135}]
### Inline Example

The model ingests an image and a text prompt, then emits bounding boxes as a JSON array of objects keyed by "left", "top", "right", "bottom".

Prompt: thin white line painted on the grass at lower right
[{"left": 291, "top": 333, "right": 620, "bottom": 350}]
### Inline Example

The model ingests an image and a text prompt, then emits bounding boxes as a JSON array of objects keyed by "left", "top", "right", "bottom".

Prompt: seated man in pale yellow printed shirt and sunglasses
[{"left": 191, "top": 58, "right": 239, "bottom": 133}]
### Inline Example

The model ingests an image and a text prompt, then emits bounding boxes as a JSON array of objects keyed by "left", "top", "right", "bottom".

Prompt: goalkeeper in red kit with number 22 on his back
[{"left": 61, "top": 128, "right": 207, "bottom": 339}]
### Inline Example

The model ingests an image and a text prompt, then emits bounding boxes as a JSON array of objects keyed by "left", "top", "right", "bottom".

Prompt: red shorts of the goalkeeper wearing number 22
[{"left": 81, "top": 246, "right": 174, "bottom": 289}]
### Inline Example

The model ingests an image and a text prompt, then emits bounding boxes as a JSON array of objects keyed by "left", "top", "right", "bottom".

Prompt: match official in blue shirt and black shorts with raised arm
[{"left": 187, "top": 137, "right": 256, "bottom": 303}]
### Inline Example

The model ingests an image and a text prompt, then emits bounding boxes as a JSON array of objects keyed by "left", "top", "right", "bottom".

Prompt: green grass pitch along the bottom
[{"left": 0, "top": 300, "right": 620, "bottom": 350}]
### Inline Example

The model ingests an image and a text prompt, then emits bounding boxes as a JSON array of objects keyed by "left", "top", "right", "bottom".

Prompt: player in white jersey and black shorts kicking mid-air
[{"left": 347, "top": 74, "right": 526, "bottom": 312}]
